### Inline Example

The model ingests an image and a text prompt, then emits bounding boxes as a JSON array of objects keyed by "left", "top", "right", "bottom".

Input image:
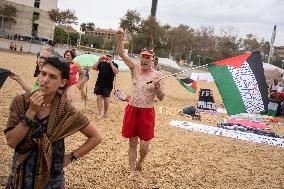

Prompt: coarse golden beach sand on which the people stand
[{"left": 0, "top": 52, "right": 284, "bottom": 189}]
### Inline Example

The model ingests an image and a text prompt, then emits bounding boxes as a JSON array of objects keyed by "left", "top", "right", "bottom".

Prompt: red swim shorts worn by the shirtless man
[{"left": 121, "top": 105, "right": 155, "bottom": 141}]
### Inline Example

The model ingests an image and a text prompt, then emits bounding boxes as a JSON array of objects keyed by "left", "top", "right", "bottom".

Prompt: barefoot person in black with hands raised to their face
[{"left": 93, "top": 55, "right": 118, "bottom": 118}]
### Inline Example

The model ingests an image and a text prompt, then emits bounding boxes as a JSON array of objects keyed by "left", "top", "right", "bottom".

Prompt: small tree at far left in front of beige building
[{"left": 0, "top": 4, "right": 18, "bottom": 37}]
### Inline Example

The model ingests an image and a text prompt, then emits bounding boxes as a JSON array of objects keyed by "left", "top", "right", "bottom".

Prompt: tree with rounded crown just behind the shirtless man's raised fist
[{"left": 120, "top": 10, "right": 141, "bottom": 56}]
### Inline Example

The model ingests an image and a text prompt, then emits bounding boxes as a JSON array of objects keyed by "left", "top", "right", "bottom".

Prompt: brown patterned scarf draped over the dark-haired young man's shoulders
[{"left": 4, "top": 93, "right": 89, "bottom": 189}]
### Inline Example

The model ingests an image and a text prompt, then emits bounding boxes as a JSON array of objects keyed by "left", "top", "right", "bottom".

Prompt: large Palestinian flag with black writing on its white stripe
[{"left": 208, "top": 51, "right": 268, "bottom": 115}]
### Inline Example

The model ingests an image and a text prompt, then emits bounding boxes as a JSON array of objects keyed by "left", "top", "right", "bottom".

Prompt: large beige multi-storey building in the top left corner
[{"left": 0, "top": 0, "right": 58, "bottom": 41}]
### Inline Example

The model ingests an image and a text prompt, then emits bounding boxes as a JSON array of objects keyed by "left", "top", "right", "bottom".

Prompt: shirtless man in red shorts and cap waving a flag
[{"left": 116, "top": 29, "right": 165, "bottom": 178}]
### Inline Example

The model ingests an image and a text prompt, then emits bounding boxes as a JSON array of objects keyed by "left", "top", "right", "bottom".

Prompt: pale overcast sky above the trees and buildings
[{"left": 58, "top": 0, "right": 284, "bottom": 46}]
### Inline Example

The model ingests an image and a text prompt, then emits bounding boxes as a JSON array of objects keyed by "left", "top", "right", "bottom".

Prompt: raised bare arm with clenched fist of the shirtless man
[{"left": 116, "top": 29, "right": 135, "bottom": 69}]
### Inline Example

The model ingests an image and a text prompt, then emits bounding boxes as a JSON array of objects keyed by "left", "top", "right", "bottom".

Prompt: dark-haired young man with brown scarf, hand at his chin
[{"left": 4, "top": 57, "right": 101, "bottom": 189}]
